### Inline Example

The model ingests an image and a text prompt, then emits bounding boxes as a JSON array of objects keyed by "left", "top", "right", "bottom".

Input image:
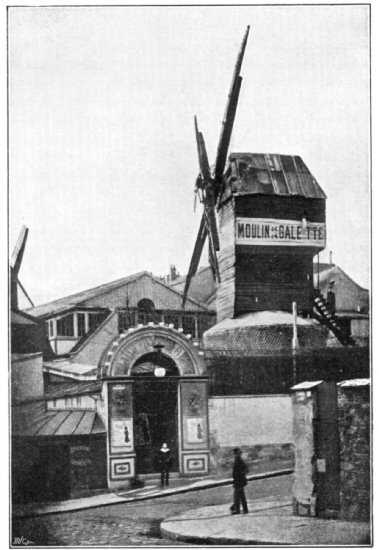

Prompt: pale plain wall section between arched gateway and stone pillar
[{"left": 208, "top": 395, "right": 293, "bottom": 447}]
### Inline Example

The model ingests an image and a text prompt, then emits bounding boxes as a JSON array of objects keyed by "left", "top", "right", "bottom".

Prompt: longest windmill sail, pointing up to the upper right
[{"left": 214, "top": 25, "right": 250, "bottom": 199}]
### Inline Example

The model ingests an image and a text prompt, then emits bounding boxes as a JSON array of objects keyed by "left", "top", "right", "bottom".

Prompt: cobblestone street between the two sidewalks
[{"left": 12, "top": 476, "right": 291, "bottom": 547}]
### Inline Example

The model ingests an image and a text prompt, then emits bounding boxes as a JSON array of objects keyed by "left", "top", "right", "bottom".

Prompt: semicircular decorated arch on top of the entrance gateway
[{"left": 99, "top": 324, "right": 205, "bottom": 377}]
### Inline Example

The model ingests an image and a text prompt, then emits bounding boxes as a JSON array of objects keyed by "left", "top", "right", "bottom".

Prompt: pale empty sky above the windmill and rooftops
[{"left": 8, "top": 5, "right": 371, "bottom": 307}]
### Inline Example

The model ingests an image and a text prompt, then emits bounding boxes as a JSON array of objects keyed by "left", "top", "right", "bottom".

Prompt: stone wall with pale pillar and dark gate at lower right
[{"left": 292, "top": 378, "right": 371, "bottom": 521}]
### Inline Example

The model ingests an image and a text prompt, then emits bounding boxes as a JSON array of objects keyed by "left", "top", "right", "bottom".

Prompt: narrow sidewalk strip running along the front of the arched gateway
[{"left": 13, "top": 469, "right": 293, "bottom": 517}]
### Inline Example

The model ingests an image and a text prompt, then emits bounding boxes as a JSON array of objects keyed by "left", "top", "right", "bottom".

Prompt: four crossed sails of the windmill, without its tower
[{"left": 182, "top": 26, "right": 250, "bottom": 307}]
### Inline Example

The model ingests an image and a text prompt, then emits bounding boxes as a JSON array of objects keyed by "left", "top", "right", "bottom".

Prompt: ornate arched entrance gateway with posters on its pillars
[{"left": 99, "top": 324, "right": 209, "bottom": 487}]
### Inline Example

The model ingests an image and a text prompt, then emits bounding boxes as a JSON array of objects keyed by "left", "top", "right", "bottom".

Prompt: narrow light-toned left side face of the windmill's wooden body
[{"left": 216, "top": 199, "right": 235, "bottom": 322}]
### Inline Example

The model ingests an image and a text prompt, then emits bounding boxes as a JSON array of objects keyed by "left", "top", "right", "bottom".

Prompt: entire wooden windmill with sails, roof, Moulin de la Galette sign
[{"left": 183, "top": 27, "right": 352, "bottom": 344}]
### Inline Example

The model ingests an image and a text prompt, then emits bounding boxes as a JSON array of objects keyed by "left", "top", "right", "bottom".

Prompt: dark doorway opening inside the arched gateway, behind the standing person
[{"left": 132, "top": 352, "right": 179, "bottom": 474}]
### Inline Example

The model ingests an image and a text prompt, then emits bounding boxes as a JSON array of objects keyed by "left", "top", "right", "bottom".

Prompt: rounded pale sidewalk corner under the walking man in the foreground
[{"left": 161, "top": 498, "right": 370, "bottom": 546}]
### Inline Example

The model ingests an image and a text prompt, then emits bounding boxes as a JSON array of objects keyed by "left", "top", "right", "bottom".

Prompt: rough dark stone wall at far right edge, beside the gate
[{"left": 338, "top": 381, "right": 370, "bottom": 521}]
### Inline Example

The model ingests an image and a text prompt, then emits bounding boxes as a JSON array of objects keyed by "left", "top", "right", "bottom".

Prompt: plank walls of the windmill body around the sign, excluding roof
[{"left": 216, "top": 194, "right": 325, "bottom": 322}]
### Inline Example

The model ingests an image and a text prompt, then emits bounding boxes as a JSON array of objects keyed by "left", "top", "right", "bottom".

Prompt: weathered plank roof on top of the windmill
[{"left": 225, "top": 153, "right": 326, "bottom": 199}]
